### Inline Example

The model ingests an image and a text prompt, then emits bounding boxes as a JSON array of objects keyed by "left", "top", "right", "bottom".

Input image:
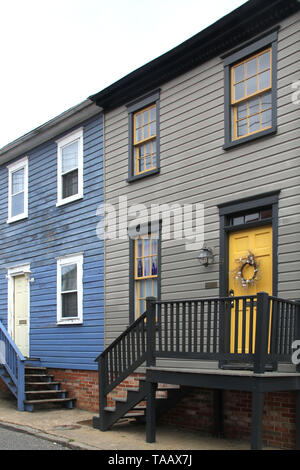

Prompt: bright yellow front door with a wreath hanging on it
[{"left": 228, "top": 226, "right": 273, "bottom": 353}]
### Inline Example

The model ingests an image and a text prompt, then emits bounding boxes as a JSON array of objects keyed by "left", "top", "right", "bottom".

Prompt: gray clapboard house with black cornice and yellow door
[{"left": 90, "top": 0, "right": 300, "bottom": 449}]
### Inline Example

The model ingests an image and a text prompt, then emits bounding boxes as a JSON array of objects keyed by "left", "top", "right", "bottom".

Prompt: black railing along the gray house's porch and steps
[{"left": 96, "top": 292, "right": 300, "bottom": 429}]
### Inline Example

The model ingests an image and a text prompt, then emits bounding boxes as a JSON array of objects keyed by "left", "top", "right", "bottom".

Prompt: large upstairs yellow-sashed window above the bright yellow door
[{"left": 224, "top": 31, "right": 278, "bottom": 149}]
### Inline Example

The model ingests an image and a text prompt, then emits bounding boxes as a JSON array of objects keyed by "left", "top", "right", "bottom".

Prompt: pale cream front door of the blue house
[{"left": 14, "top": 274, "right": 29, "bottom": 357}]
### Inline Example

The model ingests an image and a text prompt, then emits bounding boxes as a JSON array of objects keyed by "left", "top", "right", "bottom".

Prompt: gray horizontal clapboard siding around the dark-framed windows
[{"left": 105, "top": 13, "right": 300, "bottom": 367}]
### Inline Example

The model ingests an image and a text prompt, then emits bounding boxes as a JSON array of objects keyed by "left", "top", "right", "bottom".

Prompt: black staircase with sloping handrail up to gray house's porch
[{"left": 93, "top": 306, "right": 189, "bottom": 431}]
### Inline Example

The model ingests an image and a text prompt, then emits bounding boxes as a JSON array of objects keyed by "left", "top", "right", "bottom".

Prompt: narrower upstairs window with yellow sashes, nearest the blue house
[{"left": 127, "top": 91, "right": 160, "bottom": 182}]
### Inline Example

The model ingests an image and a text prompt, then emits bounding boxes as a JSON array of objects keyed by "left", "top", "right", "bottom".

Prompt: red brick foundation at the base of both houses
[{"left": 38, "top": 369, "right": 295, "bottom": 449}]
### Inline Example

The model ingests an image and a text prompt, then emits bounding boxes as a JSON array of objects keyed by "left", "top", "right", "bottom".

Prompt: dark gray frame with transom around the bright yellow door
[{"left": 218, "top": 190, "right": 280, "bottom": 297}]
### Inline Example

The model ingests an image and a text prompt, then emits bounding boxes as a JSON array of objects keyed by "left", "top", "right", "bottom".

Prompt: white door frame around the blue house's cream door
[{"left": 6, "top": 264, "right": 31, "bottom": 354}]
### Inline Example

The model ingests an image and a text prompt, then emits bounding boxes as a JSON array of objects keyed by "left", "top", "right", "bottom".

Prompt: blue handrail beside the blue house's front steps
[{"left": 0, "top": 321, "right": 26, "bottom": 411}]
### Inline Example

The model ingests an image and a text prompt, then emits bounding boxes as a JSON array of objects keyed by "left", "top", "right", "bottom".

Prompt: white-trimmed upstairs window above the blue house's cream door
[{"left": 7, "top": 157, "right": 28, "bottom": 223}]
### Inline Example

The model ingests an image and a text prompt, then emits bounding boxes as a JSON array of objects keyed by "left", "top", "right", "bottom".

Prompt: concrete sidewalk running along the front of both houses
[{"left": 0, "top": 394, "right": 254, "bottom": 451}]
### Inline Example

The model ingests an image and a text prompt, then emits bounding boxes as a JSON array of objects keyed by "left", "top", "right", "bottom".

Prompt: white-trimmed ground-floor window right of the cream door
[{"left": 57, "top": 254, "right": 83, "bottom": 324}]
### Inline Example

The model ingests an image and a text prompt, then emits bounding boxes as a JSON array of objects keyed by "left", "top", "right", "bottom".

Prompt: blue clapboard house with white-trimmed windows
[{"left": 0, "top": 100, "right": 104, "bottom": 411}]
